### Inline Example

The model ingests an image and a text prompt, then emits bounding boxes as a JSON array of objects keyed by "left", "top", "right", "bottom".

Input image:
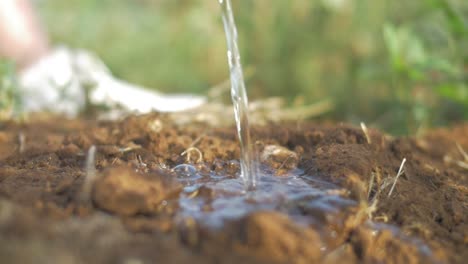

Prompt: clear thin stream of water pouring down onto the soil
[{"left": 218, "top": 0, "right": 258, "bottom": 190}]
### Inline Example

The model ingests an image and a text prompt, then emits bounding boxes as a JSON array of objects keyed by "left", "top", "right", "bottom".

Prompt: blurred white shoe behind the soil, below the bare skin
[{"left": 19, "top": 47, "right": 206, "bottom": 117}]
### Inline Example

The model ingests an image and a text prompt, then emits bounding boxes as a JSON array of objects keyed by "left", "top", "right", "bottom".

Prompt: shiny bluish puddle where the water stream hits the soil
[{"left": 173, "top": 164, "right": 346, "bottom": 227}]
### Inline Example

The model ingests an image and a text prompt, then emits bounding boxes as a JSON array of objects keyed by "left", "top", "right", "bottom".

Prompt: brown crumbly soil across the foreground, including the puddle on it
[{"left": 0, "top": 114, "right": 468, "bottom": 263}]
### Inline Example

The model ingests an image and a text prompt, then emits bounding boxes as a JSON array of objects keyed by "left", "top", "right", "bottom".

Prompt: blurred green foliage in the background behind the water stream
[{"left": 39, "top": 0, "right": 468, "bottom": 133}]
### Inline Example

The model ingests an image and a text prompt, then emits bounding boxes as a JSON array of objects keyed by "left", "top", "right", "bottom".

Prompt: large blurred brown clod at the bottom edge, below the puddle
[{"left": 198, "top": 211, "right": 322, "bottom": 263}]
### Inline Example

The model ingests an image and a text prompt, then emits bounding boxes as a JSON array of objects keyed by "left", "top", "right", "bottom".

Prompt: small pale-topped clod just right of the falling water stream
[{"left": 260, "top": 145, "right": 299, "bottom": 175}]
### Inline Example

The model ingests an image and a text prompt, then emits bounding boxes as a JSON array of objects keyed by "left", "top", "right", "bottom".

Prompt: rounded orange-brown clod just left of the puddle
[{"left": 93, "top": 167, "right": 182, "bottom": 216}]
